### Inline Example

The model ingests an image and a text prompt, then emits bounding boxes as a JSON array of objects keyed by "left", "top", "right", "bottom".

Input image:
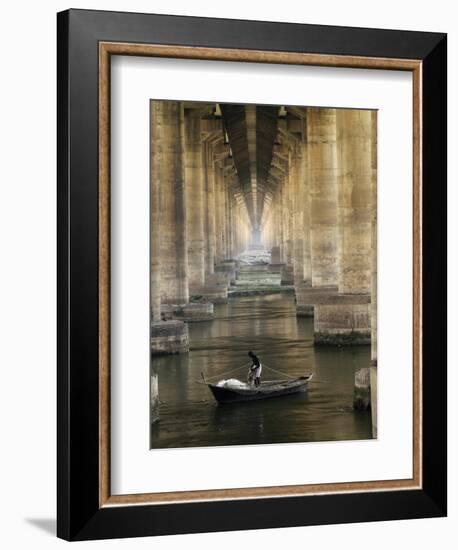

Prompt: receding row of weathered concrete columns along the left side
[{"left": 150, "top": 101, "right": 251, "bottom": 354}]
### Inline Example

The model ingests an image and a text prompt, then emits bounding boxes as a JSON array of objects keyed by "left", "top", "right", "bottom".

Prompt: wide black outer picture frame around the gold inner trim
[{"left": 57, "top": 10, "right": 447, "bottom": 540}]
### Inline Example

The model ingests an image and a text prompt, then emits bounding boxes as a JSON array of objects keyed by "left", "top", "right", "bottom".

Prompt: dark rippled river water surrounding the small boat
[{"left": 151, "top": 294, "right": 372, "bottom": 448}]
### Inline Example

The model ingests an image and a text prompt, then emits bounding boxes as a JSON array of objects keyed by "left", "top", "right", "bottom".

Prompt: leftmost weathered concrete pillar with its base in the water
[{"left": 150, "top": 101, "right": 189, "bottom": 355}]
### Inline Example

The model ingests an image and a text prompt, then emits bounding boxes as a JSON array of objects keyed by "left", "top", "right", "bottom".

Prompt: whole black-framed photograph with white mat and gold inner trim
[{"left": 58, "top": 10, "right": 447, "bottom": 540}]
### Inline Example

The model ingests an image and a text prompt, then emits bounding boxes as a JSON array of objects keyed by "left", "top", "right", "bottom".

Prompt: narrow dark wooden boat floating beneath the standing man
[{"left": 205, "top": 374, "right": 313, "bottom": 403}]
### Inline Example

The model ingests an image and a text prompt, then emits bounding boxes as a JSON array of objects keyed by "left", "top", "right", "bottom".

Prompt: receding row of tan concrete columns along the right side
[{"left": 262, "top": 108, "right": 376, "bottom": 345}]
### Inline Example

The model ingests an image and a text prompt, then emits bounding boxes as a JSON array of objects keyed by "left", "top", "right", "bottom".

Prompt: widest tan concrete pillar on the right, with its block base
[{"left": 315, "top": 109, "right": 375, "bottom": 348}]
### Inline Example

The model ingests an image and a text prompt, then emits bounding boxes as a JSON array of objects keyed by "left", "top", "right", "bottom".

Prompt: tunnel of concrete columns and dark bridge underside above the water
[{"left": 151, "top": 101, "right": 377, "bottom": 365}]
